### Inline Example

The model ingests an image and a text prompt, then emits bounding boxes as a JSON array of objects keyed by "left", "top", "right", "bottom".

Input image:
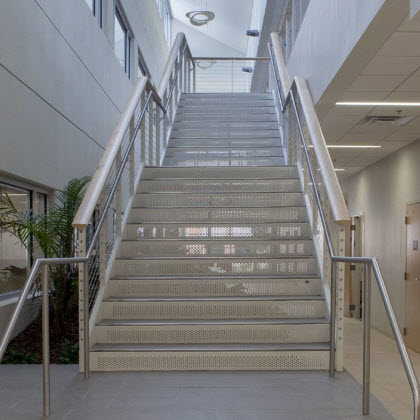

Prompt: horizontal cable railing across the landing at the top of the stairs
[{"left": 194, "top": 57, "right": 269, "bottom": 93}]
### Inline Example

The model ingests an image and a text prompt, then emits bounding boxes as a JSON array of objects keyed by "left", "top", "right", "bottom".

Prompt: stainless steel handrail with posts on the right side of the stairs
[{"left": 268, "top": 43, "right": 420, "bottom": 420}]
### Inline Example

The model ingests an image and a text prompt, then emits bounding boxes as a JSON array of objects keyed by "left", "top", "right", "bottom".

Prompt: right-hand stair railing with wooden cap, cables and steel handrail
[{"left": 268, "top": 33, "right": 420, "bottom": 420}]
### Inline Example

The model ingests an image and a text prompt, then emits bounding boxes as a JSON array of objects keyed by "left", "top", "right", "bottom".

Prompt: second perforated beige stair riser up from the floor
[{"left": 93, "top": 324, "right": 330, "bottom": 344}]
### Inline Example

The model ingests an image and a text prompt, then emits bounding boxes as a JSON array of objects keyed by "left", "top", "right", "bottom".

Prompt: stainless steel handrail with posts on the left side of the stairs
[{"left": 0, "top": 33, "right": 189, "bottom": 416}]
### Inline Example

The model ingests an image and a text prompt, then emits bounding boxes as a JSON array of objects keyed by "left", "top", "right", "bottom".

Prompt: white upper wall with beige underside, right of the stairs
[{"left": 287, "top": 0, "right": 409, "bottom": 117}]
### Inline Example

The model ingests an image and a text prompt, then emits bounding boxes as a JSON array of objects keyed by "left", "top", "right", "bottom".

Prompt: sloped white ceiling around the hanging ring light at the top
[{"left": 170, "top": 0, "right": 253, "bottom": 54}]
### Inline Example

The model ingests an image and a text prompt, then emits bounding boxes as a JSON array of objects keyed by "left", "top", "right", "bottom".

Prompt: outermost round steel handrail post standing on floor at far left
[{"left": 42, "top": 264, "right": 50, "bottom": 417}]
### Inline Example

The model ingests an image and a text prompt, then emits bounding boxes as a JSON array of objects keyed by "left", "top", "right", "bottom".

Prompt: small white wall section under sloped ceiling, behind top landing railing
[{"left": 171, "top": 19, "right": 245, "bottom": 57}]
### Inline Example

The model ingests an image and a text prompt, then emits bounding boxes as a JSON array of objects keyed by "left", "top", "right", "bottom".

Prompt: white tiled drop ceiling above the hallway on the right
[{"left": 321, "top": 14, "right": 420, "bottom": 179}]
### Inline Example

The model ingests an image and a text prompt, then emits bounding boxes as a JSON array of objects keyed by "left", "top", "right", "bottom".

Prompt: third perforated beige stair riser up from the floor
[{"left": 101, "top": 299, "right": 327, "bottom": 319}]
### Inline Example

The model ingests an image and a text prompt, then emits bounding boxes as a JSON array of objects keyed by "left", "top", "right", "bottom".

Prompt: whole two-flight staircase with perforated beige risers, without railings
[{"left": 90, "top": 93, "right": 329, "bottom": 371}]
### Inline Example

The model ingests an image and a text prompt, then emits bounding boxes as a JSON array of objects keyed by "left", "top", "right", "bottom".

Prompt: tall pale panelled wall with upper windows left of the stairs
[{"left": 0, "top": 0, "right": 168, "bottom": 188}]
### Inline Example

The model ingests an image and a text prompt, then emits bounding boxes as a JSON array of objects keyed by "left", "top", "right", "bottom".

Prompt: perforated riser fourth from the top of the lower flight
[{"left": 129, "top": 206, "right": 307, "bottom": 223}]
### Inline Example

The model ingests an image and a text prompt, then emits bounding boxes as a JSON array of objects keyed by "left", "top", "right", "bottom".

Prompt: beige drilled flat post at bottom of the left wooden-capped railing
[{"left": 77, "top": 229, "right": 89, "bottom": 372}]
